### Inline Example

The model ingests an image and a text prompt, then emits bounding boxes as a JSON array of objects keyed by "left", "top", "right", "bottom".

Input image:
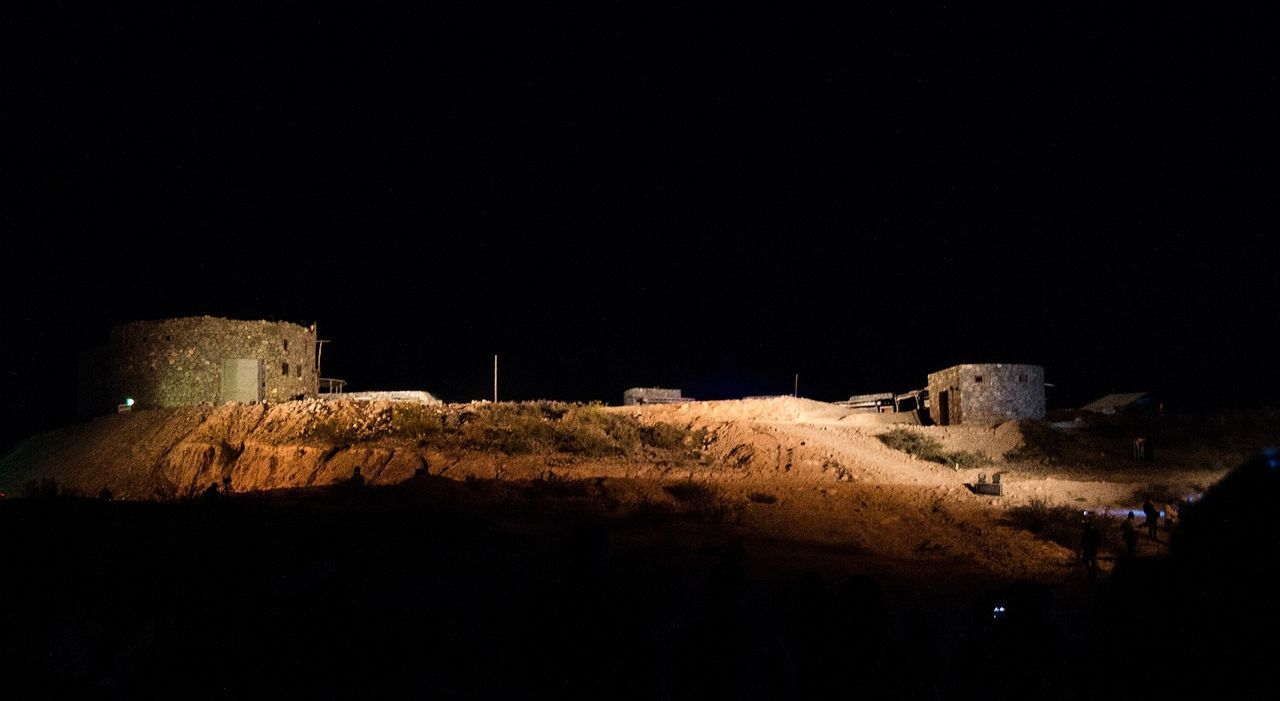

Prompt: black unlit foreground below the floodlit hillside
[{"left": 0, "top": 463, "right": 1276, "bottom": 698}]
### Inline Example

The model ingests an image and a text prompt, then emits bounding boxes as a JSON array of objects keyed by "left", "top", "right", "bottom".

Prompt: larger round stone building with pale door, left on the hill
[{"left": 79, "top": 316, "right": 320, "bottom": 416}]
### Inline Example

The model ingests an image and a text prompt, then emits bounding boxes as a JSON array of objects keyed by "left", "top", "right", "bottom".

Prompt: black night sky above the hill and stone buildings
[{"left": 0, "top": 3, "right": 1280, "bottom": 442}]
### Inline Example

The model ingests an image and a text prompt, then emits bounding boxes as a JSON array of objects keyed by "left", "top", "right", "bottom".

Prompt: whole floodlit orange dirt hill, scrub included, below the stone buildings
[{"left": 0, "top": 397, "right": 1239, "bottom": 579}]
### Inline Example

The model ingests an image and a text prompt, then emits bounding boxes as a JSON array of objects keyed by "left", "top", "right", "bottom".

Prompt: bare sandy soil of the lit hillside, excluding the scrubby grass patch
[{"left": 0, "top": 397, "right": 1225, "bottom": 582}]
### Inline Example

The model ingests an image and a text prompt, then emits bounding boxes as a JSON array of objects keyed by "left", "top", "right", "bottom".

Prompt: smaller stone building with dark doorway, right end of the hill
[{"left": 929, "top": 363, "right": 1044, "bottom": 426}]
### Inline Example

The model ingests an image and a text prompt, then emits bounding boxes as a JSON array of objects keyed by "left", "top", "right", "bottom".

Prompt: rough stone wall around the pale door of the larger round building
[{"left": 106, "top": 316, "right": 319, "bottom": 408}]
